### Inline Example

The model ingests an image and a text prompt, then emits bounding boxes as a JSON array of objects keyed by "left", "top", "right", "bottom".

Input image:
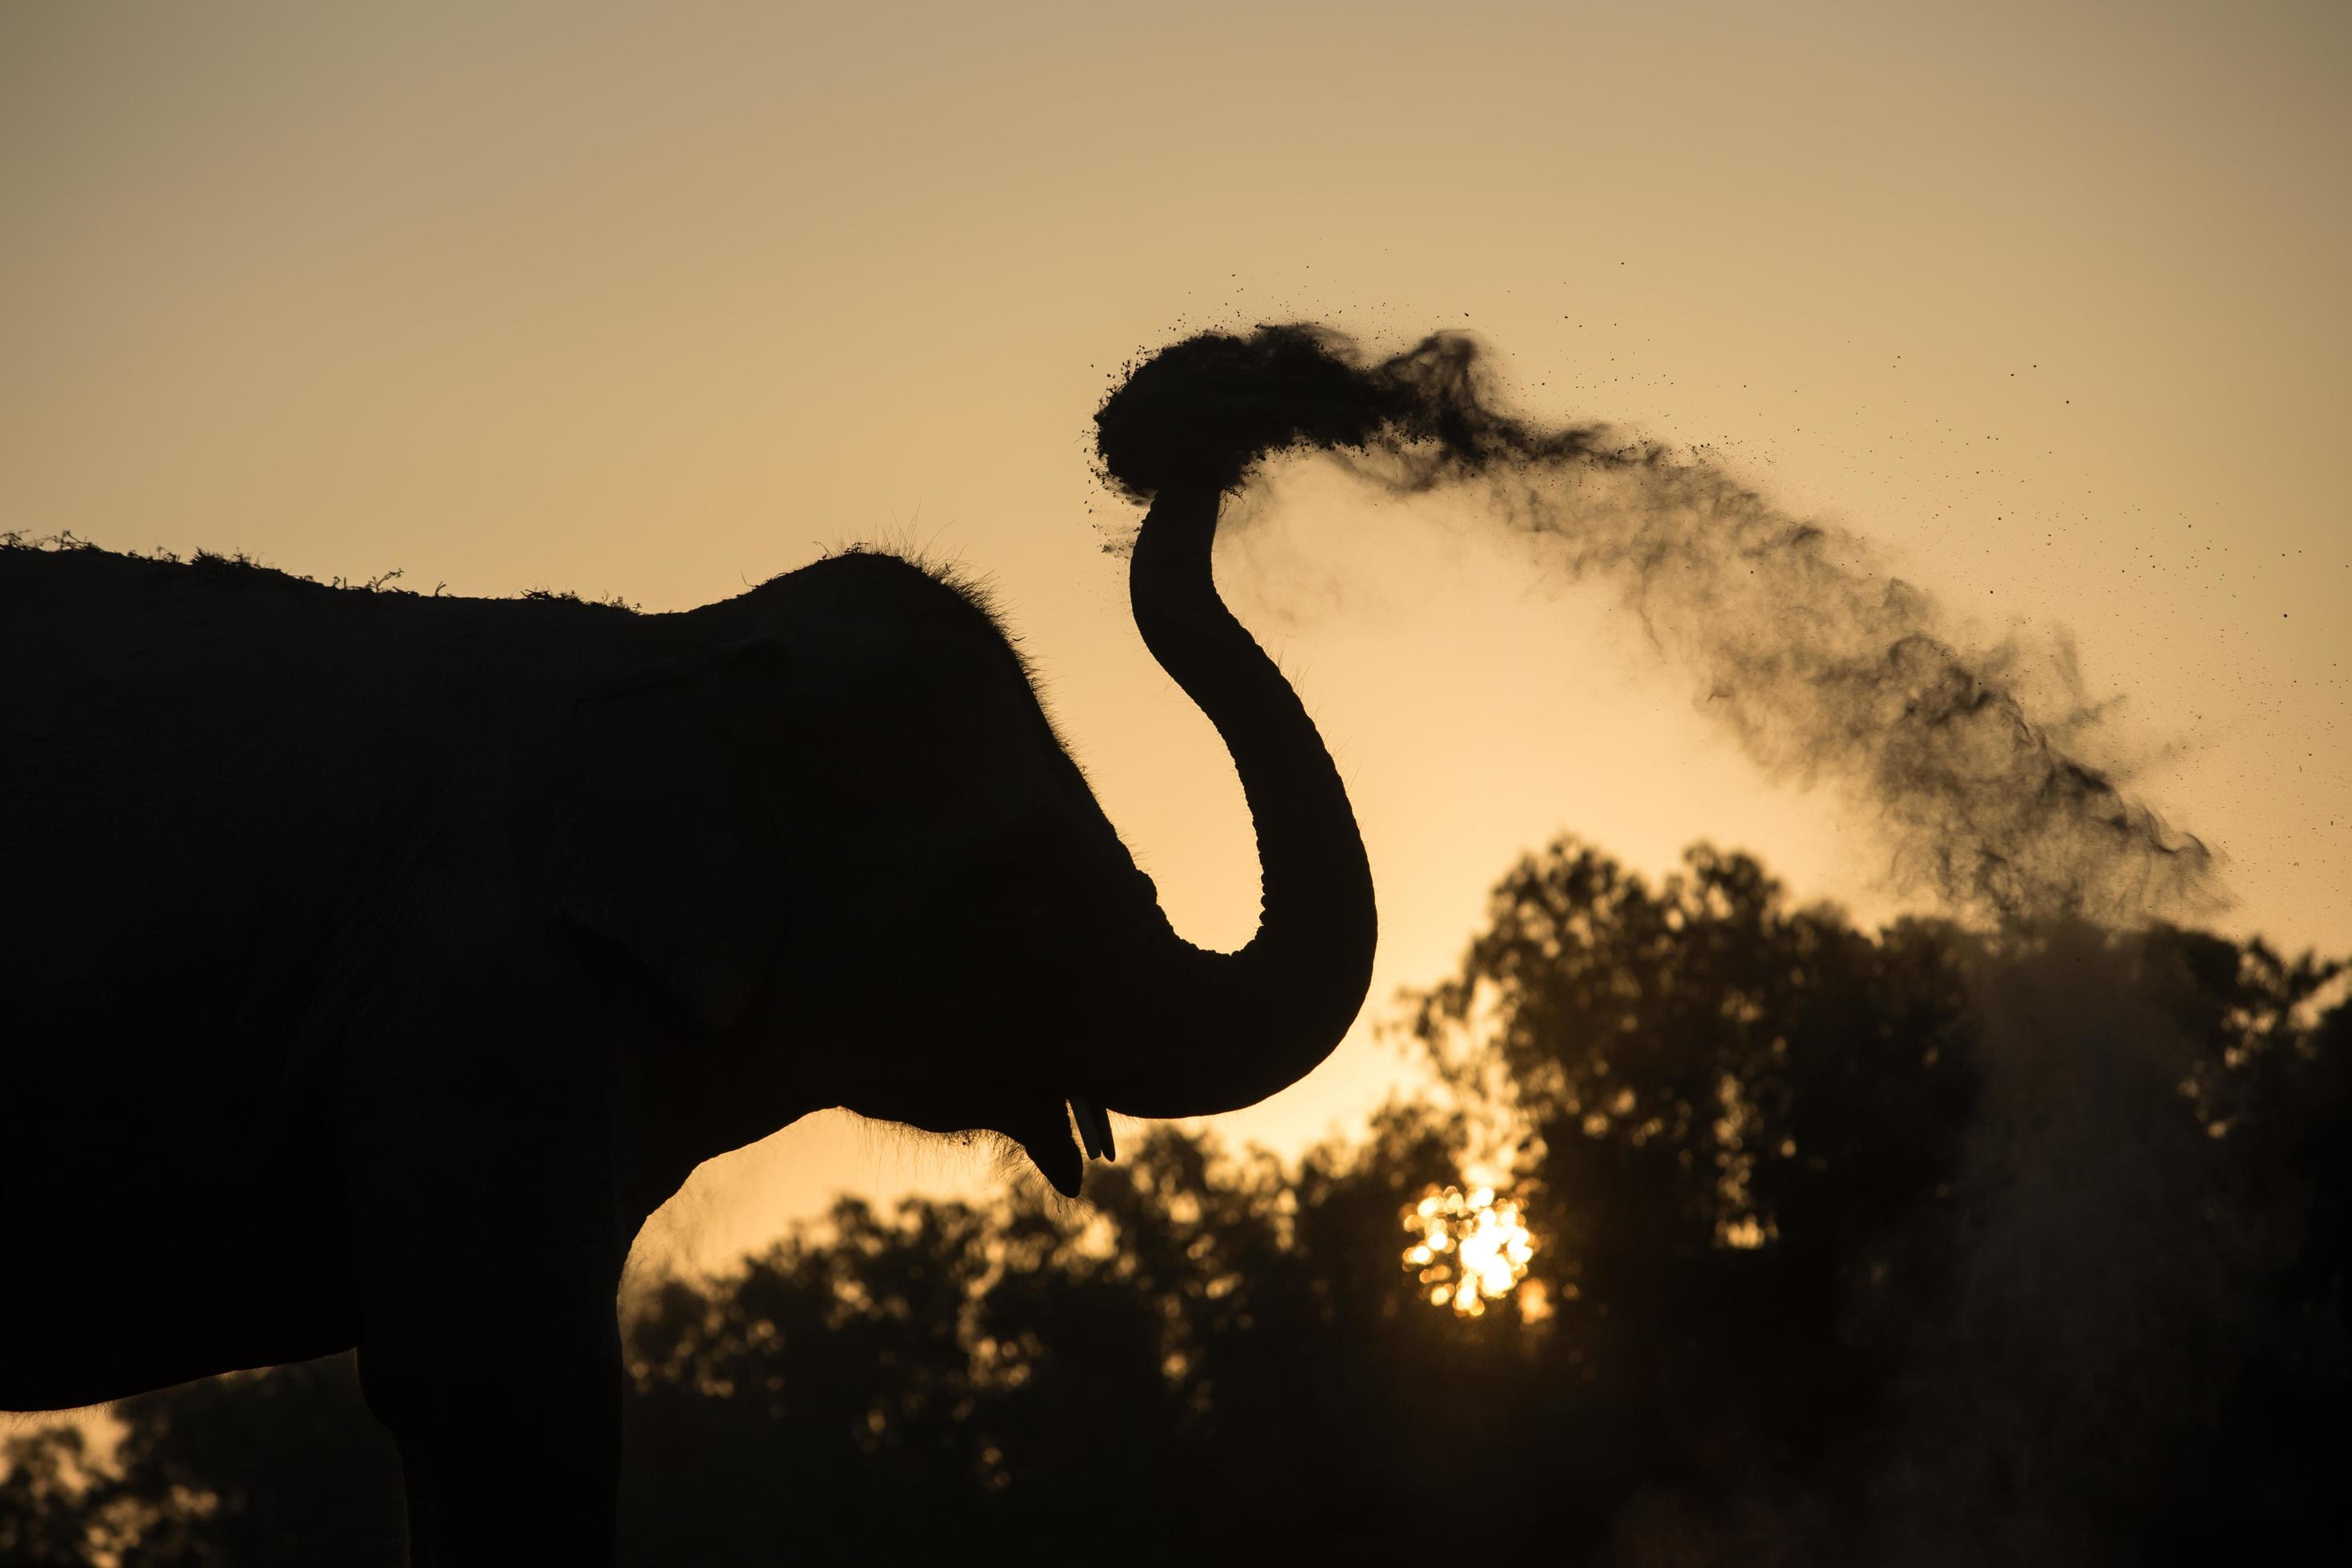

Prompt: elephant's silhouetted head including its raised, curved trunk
[{"left": 553, "top": 486, "right": 1376, "bottom": 1194}]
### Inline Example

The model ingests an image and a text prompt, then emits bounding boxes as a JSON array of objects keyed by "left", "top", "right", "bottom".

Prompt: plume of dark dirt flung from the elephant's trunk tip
[{"left": 1096, "top": 325, "right": 2225, "bottom": 924}]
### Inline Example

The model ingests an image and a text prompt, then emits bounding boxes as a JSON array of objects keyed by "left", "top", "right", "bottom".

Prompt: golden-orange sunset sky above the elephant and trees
[{"left": 0, "top": 0, "right": 2352, "bottom": 1258}]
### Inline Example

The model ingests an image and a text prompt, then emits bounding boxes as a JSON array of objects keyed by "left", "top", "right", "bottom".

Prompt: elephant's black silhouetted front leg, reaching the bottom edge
[{"left": 346, "top": 1011, "right": 626, "bottom": 1568}]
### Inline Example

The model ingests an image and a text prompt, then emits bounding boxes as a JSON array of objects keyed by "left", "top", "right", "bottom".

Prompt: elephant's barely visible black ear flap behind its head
[{"left": 548, "top": 642, "right": 786, "bottom": 1027}]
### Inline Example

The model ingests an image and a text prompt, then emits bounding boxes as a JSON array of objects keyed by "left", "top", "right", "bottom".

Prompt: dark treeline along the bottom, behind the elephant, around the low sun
[{"left": 0, "top": 842, "right": 2352, "bottom": 1568}]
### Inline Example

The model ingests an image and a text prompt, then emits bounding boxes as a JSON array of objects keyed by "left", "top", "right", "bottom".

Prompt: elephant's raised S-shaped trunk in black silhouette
[{"left": 1103, "top": 489, "right": 1378, "bottom": 1117}]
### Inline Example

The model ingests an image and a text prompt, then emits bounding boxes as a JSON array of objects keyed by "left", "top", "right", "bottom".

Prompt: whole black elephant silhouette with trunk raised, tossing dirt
[{"left": 0, "top": 484, "right": 1376, "bottom": 1566}]
